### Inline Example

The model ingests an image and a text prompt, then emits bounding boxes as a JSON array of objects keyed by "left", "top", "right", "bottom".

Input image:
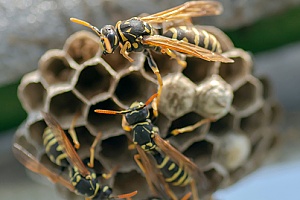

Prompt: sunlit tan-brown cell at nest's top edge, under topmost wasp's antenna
[{"left": 63, "top": 31, "right": 99, "bottom": 64}]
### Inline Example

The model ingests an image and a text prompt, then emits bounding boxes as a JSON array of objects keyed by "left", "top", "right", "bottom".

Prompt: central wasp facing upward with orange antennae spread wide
[{"left": 95, "top": 93, "right": 206, "bottom": 199}]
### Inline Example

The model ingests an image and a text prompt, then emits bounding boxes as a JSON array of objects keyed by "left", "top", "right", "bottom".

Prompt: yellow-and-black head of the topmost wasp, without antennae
[{"left": 100, "top": 25, "right": 119, "bottom": 54}]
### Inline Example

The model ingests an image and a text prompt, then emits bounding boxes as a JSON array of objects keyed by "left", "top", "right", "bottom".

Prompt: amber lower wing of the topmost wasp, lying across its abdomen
[{"left": 142, "top": 35, "right": 234, "bottom": 63}]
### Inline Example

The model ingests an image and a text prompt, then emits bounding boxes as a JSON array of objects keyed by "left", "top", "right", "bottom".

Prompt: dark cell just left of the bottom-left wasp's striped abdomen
[{"left": 28, "top": 120, "right": 47, "bottom": 146}]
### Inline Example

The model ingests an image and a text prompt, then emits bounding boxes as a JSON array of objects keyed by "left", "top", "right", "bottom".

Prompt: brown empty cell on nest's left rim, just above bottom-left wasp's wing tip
[{"left": 21, "top": 82, "right": 46, "bottom": 110}]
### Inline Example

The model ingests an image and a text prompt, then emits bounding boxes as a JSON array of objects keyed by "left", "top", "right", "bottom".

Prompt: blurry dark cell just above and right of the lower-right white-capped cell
[{"left": 240, "top": 108, "right": 268, "bottom": 137}]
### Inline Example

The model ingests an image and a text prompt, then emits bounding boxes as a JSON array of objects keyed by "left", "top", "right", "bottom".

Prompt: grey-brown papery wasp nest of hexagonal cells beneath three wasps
[{"left": 15, "top": 26, "right": 279, "bottom": 199}]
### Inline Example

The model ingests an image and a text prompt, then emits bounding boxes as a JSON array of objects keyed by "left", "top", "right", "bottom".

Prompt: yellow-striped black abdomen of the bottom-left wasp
[{"left": 43, "top": 127, "right": 69, "bottom": 167}]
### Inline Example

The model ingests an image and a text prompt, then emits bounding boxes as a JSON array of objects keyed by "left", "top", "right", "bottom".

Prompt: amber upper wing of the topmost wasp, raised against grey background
[{"left": 141, "top": 1, "right": 223, "bottom": 23}]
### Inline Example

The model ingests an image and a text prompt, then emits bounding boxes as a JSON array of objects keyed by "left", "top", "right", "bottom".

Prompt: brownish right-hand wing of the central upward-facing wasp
[{"left": 153, "top": 134, "right": 207, "bottom": 188}]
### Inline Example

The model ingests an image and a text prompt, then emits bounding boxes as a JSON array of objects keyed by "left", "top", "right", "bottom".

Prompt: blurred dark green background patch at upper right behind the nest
[{"left": 226, "top": 7, "right": 300, "bottom": 53}]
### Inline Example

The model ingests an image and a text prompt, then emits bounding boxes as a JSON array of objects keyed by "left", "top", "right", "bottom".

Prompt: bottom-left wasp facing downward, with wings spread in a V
[{"left": 13, "top": 113, "right": 137, "bottom": 200}]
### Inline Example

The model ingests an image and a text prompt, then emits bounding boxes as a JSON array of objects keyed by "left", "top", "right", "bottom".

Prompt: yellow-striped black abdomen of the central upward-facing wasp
[{"left": 152, "top": 151, "right": 191, "bottom": 186}]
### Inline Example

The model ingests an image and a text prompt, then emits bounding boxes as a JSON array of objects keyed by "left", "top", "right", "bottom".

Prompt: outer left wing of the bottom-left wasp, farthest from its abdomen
[{"left": 12, "top": 143, "right": 75, "bottom": 192}]
